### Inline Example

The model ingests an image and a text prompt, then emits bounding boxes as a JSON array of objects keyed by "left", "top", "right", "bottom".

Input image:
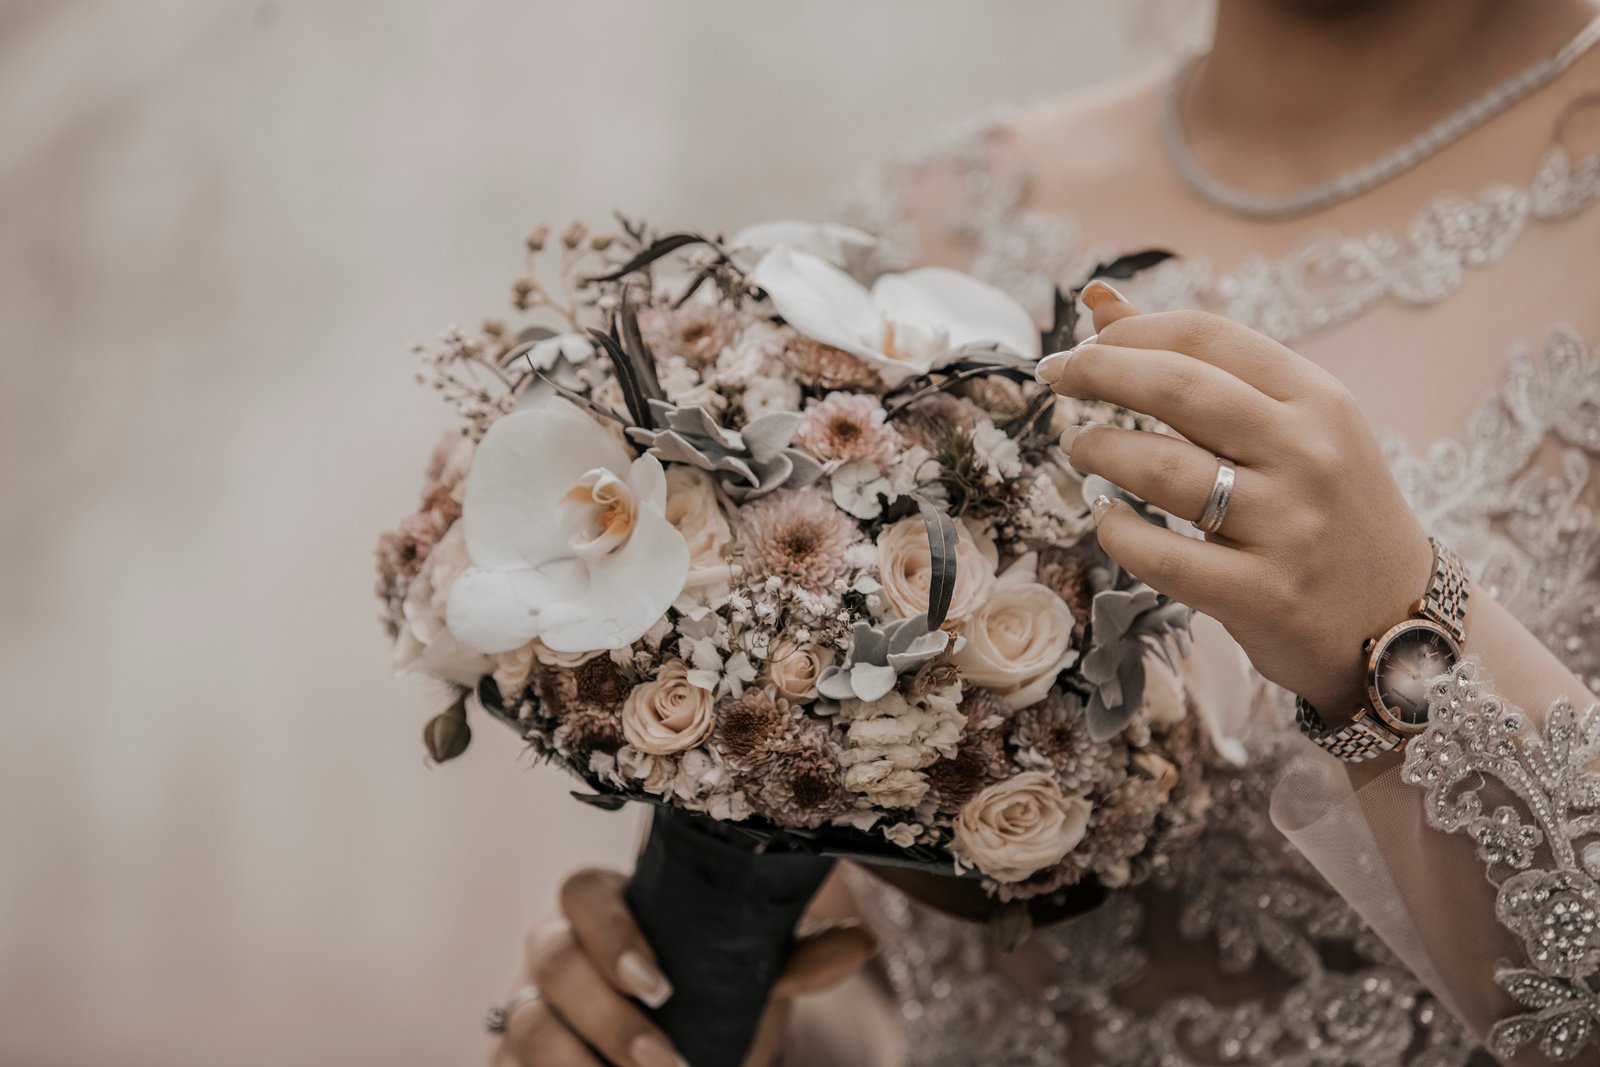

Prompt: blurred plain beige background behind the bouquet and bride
[{"left": 0, "top": 0, "right": 1158, "bottom": 1067}]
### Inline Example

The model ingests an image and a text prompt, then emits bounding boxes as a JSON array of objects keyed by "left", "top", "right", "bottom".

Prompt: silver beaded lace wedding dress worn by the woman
[{"left": 825, "top": 70, "right": 1600, "bottom": 1067}]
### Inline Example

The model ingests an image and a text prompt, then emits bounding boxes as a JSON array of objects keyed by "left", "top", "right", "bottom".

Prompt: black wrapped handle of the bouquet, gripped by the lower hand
[{"left": 627, "top": 806, "right": 834, "bottom": 1067}]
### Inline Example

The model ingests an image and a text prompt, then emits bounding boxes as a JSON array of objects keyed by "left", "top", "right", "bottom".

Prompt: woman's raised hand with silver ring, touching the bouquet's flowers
[{"left": 1038, "top": 282, "right": 1434, "bottom": 721}]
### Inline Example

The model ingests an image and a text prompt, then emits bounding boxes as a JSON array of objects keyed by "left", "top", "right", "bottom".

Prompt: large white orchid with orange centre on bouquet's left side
[{"left": 446, "top": 400, "right": 690, "bottom": 653}]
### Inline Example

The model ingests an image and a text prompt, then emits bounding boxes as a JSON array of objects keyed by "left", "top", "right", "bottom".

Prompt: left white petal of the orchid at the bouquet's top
[{"left": 750, "top": 248, "right": 885, "bottom": 363}]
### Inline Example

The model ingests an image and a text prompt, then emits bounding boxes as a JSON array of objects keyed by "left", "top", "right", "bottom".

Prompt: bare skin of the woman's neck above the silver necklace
[{"left": 1184, "top": 0, "right": 1595, "bottom": 190}]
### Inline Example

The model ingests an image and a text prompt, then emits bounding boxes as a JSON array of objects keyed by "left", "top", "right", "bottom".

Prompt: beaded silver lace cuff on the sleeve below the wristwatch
[{"left": 1402, "top": 659, "right": 1600, "bottom": 1061}]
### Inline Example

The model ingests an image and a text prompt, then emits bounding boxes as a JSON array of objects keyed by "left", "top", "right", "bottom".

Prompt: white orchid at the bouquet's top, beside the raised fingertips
[{"left": 750, "top": 246, "right": 1038, "bottom": 386}]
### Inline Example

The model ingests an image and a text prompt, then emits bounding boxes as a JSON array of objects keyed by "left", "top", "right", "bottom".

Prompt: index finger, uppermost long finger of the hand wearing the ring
[{"left": 1099, "top": 310, "right": 1331, "bottom": 400}]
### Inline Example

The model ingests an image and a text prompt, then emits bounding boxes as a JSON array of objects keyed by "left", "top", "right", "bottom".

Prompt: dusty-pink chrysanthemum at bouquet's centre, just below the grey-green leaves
[{"left": 739, "top": 490, "right": 861, "bottom": 592}]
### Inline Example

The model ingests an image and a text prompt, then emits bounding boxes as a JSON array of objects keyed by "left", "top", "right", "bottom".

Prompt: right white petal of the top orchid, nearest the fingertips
[{"left": 876, "top": 267, "right": 1038, "bottom": 358}]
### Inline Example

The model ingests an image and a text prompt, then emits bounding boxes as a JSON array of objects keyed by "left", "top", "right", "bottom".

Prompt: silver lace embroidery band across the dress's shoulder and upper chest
[{"left": 846, "top": 120, "right": 1600, "bottom": 342}]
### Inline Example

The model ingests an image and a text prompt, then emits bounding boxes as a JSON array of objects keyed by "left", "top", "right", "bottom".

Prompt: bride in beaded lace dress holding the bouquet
[{"left": 494, "top": 0, "right": 1600, "bottom": 1067}]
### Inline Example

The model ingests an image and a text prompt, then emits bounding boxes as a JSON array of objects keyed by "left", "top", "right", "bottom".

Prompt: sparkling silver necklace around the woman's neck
[{"left": 1162, "top": 18, "right": 1600, "bottom": 219}]
